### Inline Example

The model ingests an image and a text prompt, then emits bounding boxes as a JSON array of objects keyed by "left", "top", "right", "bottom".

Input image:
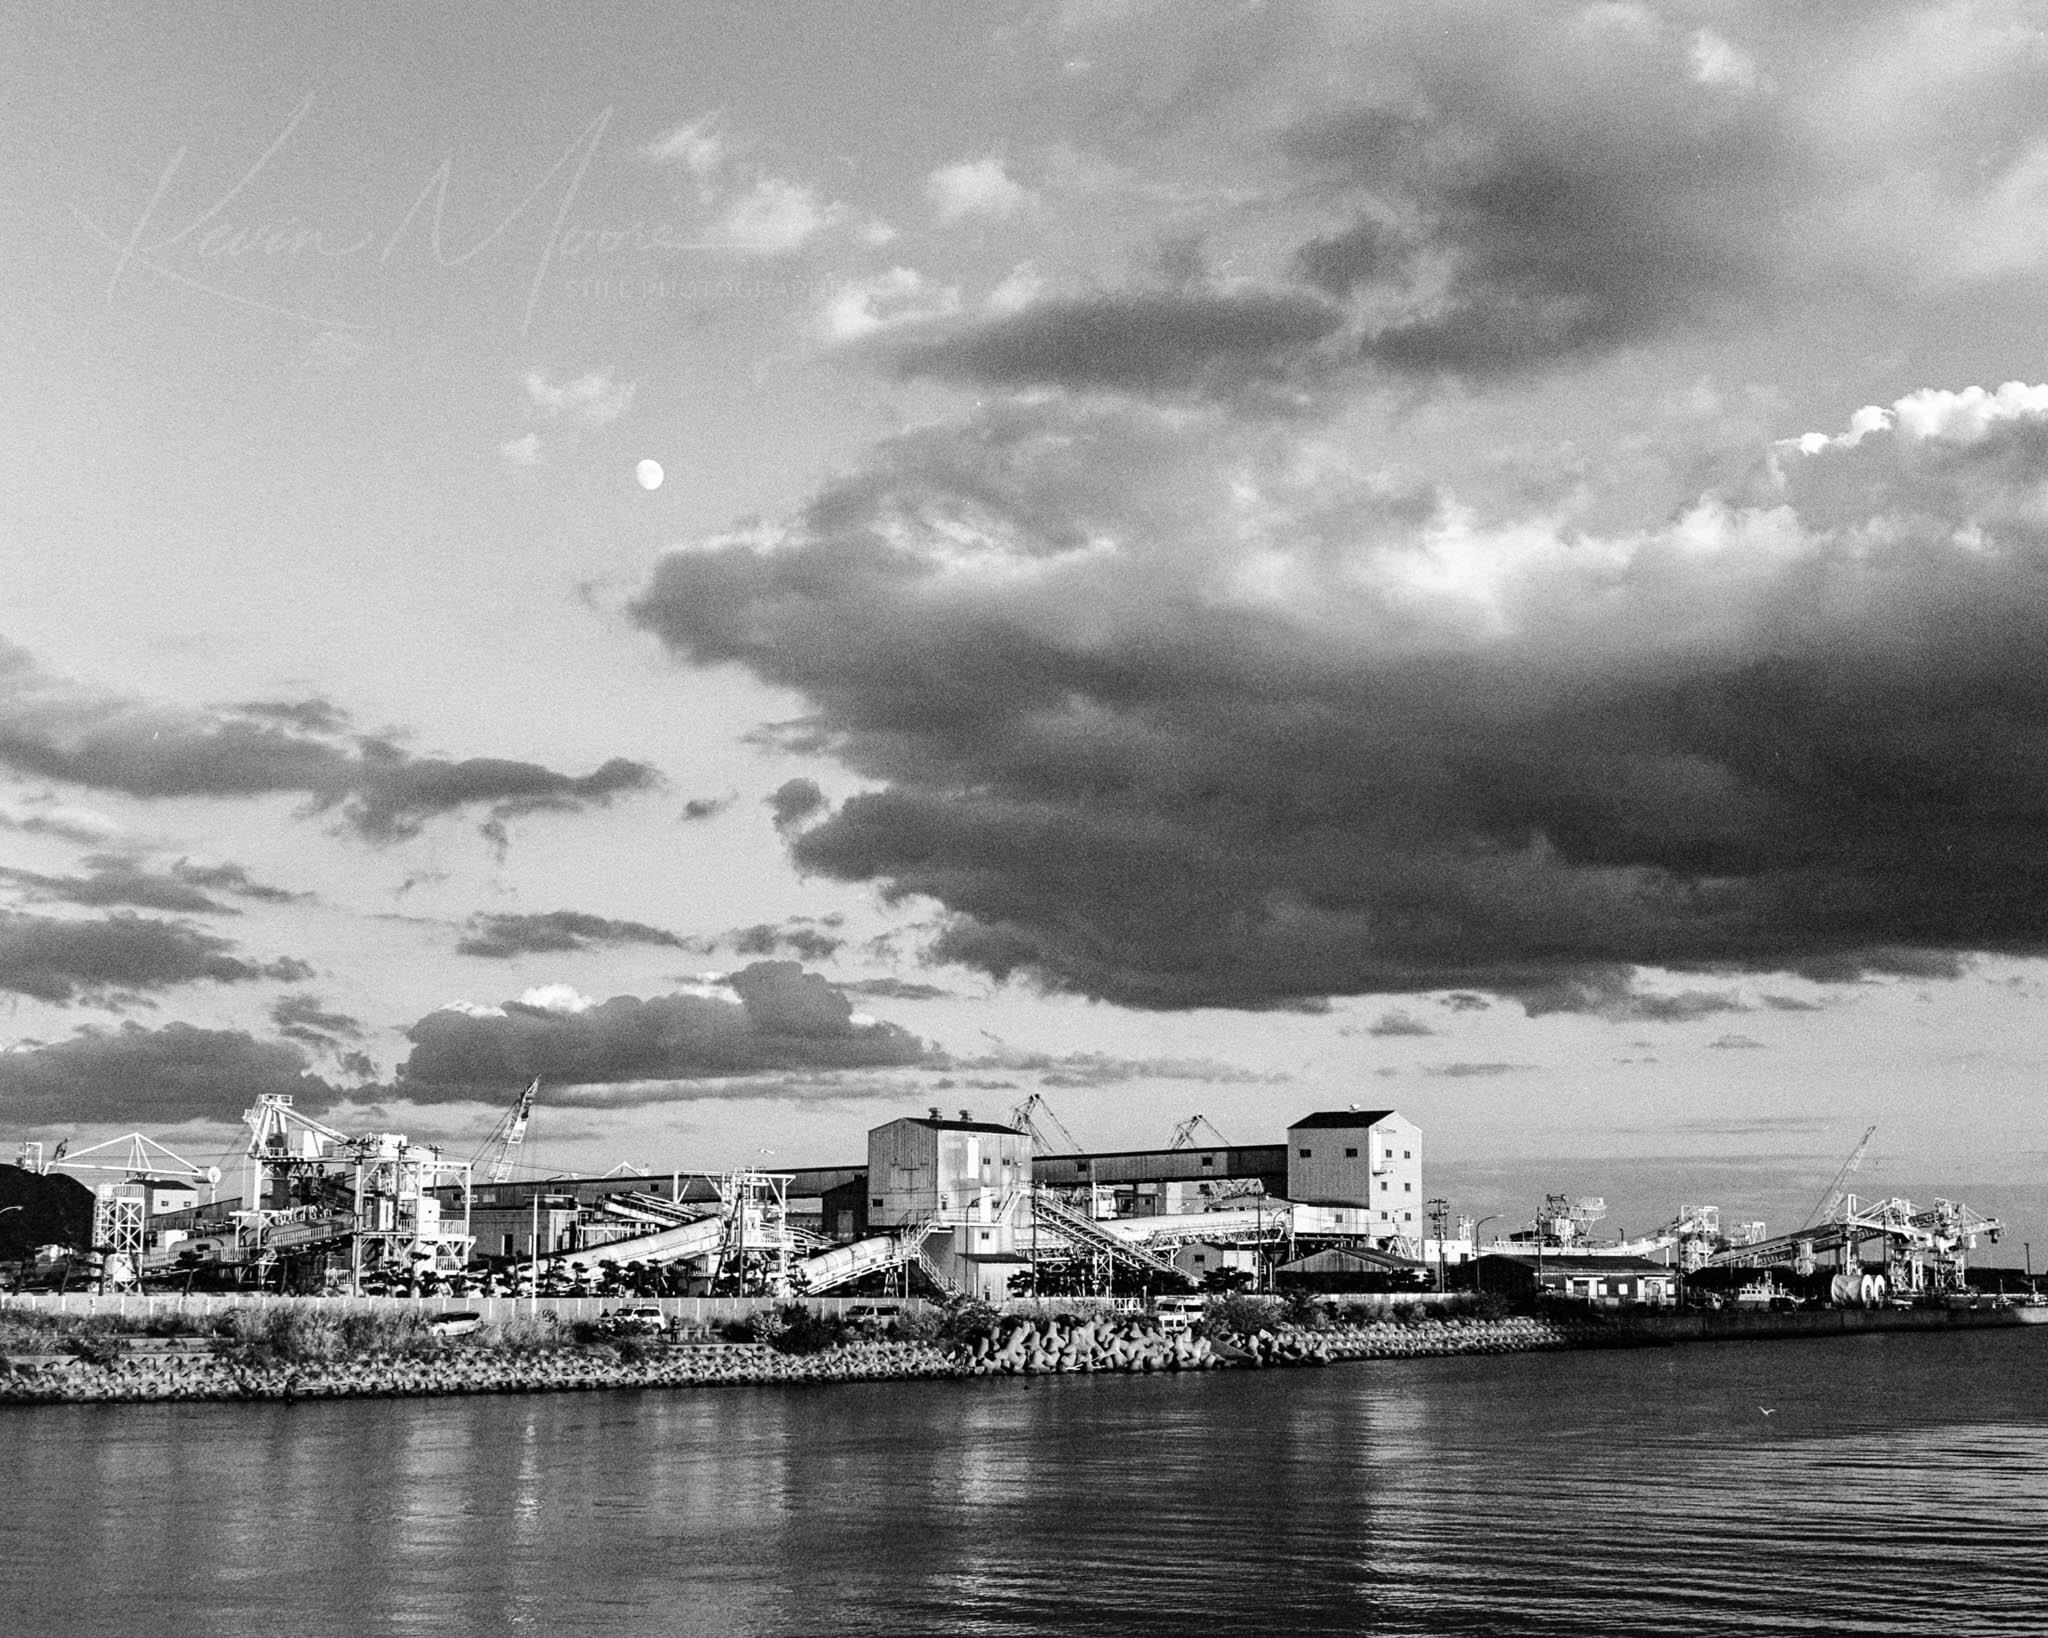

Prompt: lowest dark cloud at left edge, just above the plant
[{"left": 0, "top": 1024, "right": 334, "bottom": 1128}]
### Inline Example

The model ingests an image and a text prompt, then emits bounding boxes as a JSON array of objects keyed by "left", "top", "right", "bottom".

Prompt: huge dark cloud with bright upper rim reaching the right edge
[{"left": 635, "top": 374, "right": 2048, "bottom": 1022}]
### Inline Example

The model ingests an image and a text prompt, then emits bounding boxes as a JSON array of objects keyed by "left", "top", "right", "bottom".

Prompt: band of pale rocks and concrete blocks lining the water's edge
[{"left": 0, "top": 1317, "right": 1645, "bottom": 1405}]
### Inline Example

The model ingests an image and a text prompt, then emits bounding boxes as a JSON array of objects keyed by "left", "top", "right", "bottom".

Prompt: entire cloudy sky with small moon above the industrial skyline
[{"left": 12, "top": 0, "right": 2048, "bottom": 1261}]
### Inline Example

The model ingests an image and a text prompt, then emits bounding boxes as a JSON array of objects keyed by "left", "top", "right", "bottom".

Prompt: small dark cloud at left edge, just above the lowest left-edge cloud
[{"left": 0, "top": 911, "right": 311, "bottom": 1003}]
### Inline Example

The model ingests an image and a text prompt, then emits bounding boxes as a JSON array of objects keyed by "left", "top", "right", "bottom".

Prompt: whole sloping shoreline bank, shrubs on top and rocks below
[{"left": 0, "top": 1296, "right": 1630, "bottom": 1405}]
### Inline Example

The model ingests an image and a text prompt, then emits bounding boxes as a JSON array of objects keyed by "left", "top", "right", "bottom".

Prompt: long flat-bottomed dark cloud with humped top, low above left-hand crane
[{"left": 395, "top": 960, "right": 932, "bottom": 1102}]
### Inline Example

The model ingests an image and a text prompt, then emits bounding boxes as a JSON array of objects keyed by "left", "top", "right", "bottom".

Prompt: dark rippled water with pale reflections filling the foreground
[{"left": 0, "top": 1327, "right": 2048, "bottom": 1638}]
